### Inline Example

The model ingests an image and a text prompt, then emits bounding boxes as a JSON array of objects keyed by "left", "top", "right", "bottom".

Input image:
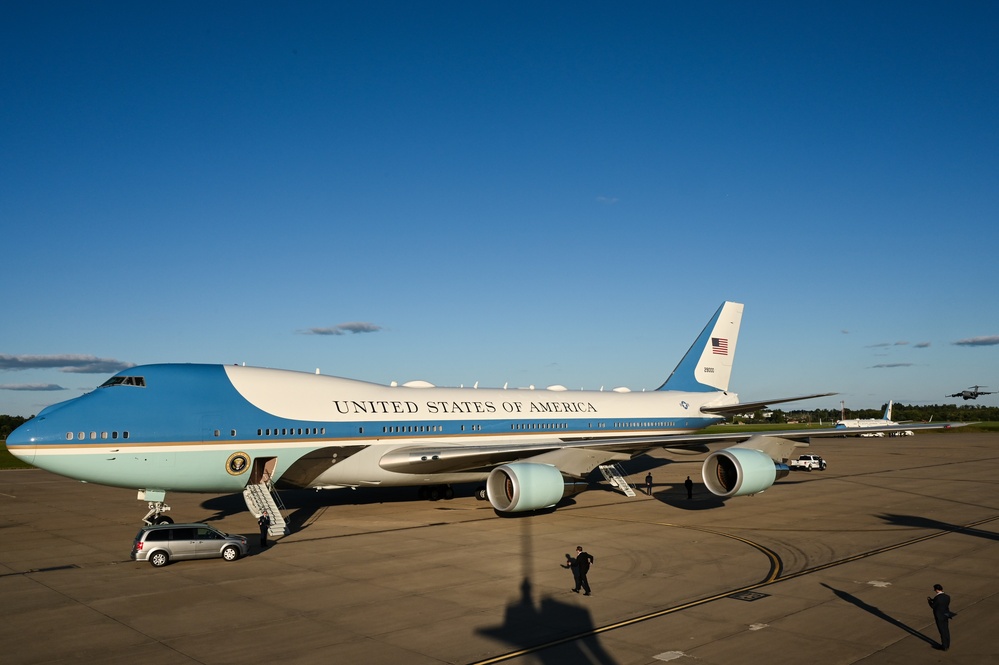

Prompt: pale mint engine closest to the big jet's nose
[{"left": 486, "top": 462, "right": 565, "bottom": 513}]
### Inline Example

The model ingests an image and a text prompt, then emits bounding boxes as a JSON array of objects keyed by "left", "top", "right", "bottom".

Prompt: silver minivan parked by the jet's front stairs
[{"left": 131, "top": 524, "right": 248, "bottom": 566}]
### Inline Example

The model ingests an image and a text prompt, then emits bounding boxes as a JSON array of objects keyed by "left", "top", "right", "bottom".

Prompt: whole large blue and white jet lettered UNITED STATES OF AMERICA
[{"left": 7, "top": 302, "right": 960, "bottom": 523}]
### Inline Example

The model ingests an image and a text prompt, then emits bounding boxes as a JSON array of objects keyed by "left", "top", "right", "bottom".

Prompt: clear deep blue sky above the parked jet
[{"left": 0, "top": 2, "right": 999, "bottom": 415}]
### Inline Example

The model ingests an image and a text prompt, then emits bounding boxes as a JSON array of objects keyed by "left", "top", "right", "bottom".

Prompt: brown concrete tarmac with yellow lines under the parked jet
[{"left": 0, "top": 432, "right": 999, "bottom": 665}]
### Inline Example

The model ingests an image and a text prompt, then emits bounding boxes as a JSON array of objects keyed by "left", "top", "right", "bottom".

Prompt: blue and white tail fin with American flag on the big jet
[{"left": 658, "top": 301, "right": 743, "bottom": 392}]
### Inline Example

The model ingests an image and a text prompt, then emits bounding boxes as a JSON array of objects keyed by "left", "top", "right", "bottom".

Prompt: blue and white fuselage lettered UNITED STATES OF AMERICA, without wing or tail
[{"left": 8, "top": 364, "right": 734, "bottom": 492}]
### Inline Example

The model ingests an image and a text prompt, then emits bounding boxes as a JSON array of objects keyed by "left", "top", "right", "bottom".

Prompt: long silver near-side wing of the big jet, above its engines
[{"left": 379, "top": 423, "right": 967, "bottom": 478}]
